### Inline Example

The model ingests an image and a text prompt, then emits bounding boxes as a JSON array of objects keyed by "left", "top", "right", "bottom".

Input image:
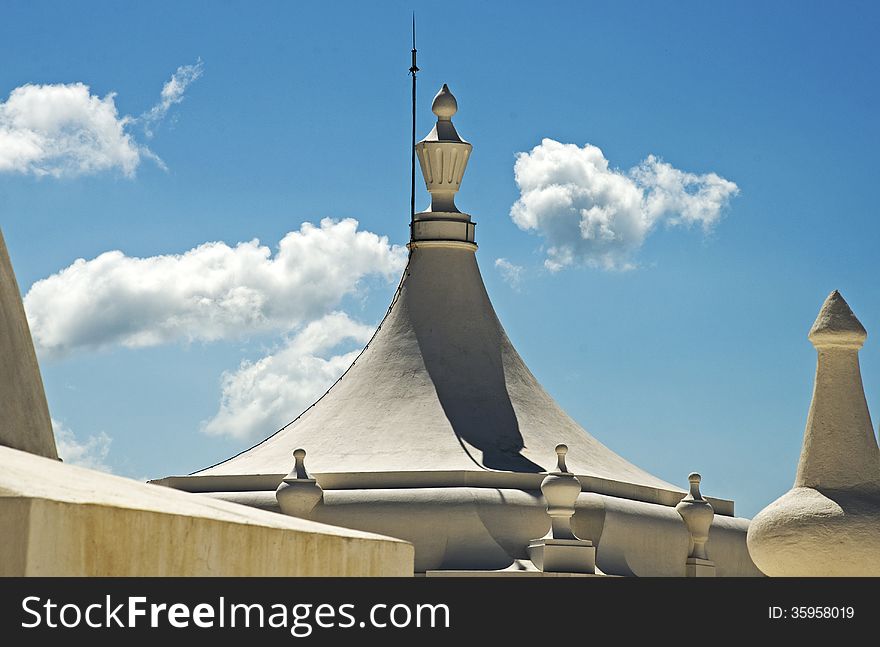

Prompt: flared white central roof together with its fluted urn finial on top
[{"left": 186, "top": 85, "right": 681, "bottom": 496}]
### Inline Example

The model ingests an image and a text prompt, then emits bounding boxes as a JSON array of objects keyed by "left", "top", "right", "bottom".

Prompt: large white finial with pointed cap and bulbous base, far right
[{"left": 746, "top": 290, "right": 880, "bottom": 577}]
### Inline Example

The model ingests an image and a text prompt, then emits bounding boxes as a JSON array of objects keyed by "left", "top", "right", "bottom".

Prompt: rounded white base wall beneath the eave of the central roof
[{"left": 201, "top": 487, "right": 761, "bottom": 577}]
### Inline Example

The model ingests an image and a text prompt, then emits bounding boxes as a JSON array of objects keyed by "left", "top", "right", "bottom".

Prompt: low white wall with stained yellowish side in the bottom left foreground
[{"left": 0, "top": 447, "right": 413, "bottom": 576}]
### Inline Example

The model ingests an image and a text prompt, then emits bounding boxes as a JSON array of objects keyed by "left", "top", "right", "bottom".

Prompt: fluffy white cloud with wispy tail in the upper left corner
[{"left": 0, "top": 61, "right": 202, "bottom": 177}]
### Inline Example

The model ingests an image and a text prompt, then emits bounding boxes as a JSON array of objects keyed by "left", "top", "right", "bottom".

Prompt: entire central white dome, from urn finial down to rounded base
[{"left": 160, "top": 87, "right": 758, "bottom": 575}]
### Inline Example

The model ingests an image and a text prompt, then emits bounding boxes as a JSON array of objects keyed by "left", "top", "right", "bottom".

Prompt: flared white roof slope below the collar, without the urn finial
[{"left": 194, "top": 246, "right": 679, "bottom": 490}]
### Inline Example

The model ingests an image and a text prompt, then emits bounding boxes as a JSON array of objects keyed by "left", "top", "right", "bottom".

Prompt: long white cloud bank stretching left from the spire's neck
[{"left": 24, "top": 218, "right": 406, "bottom": 356}]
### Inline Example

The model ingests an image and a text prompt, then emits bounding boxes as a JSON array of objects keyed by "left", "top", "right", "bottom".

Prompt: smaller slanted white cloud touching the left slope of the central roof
[{"left": 202, "top": 312, "right": 374, "bottom": 439}]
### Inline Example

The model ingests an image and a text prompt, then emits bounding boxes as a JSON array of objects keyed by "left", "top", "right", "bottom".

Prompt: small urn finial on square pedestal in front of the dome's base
[{"left": 528, "top": 444, "right": 596, "bottom": 573}]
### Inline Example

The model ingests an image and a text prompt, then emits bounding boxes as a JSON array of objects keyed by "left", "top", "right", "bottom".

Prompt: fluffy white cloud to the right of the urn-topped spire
[{"left": 510, "top": 139, "right": 739, "bottom": 271}]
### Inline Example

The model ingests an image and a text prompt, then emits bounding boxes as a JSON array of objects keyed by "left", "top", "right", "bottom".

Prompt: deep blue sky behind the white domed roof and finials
[{"left": 0, "top": 2, "right": 880, "bottom": 516}]
